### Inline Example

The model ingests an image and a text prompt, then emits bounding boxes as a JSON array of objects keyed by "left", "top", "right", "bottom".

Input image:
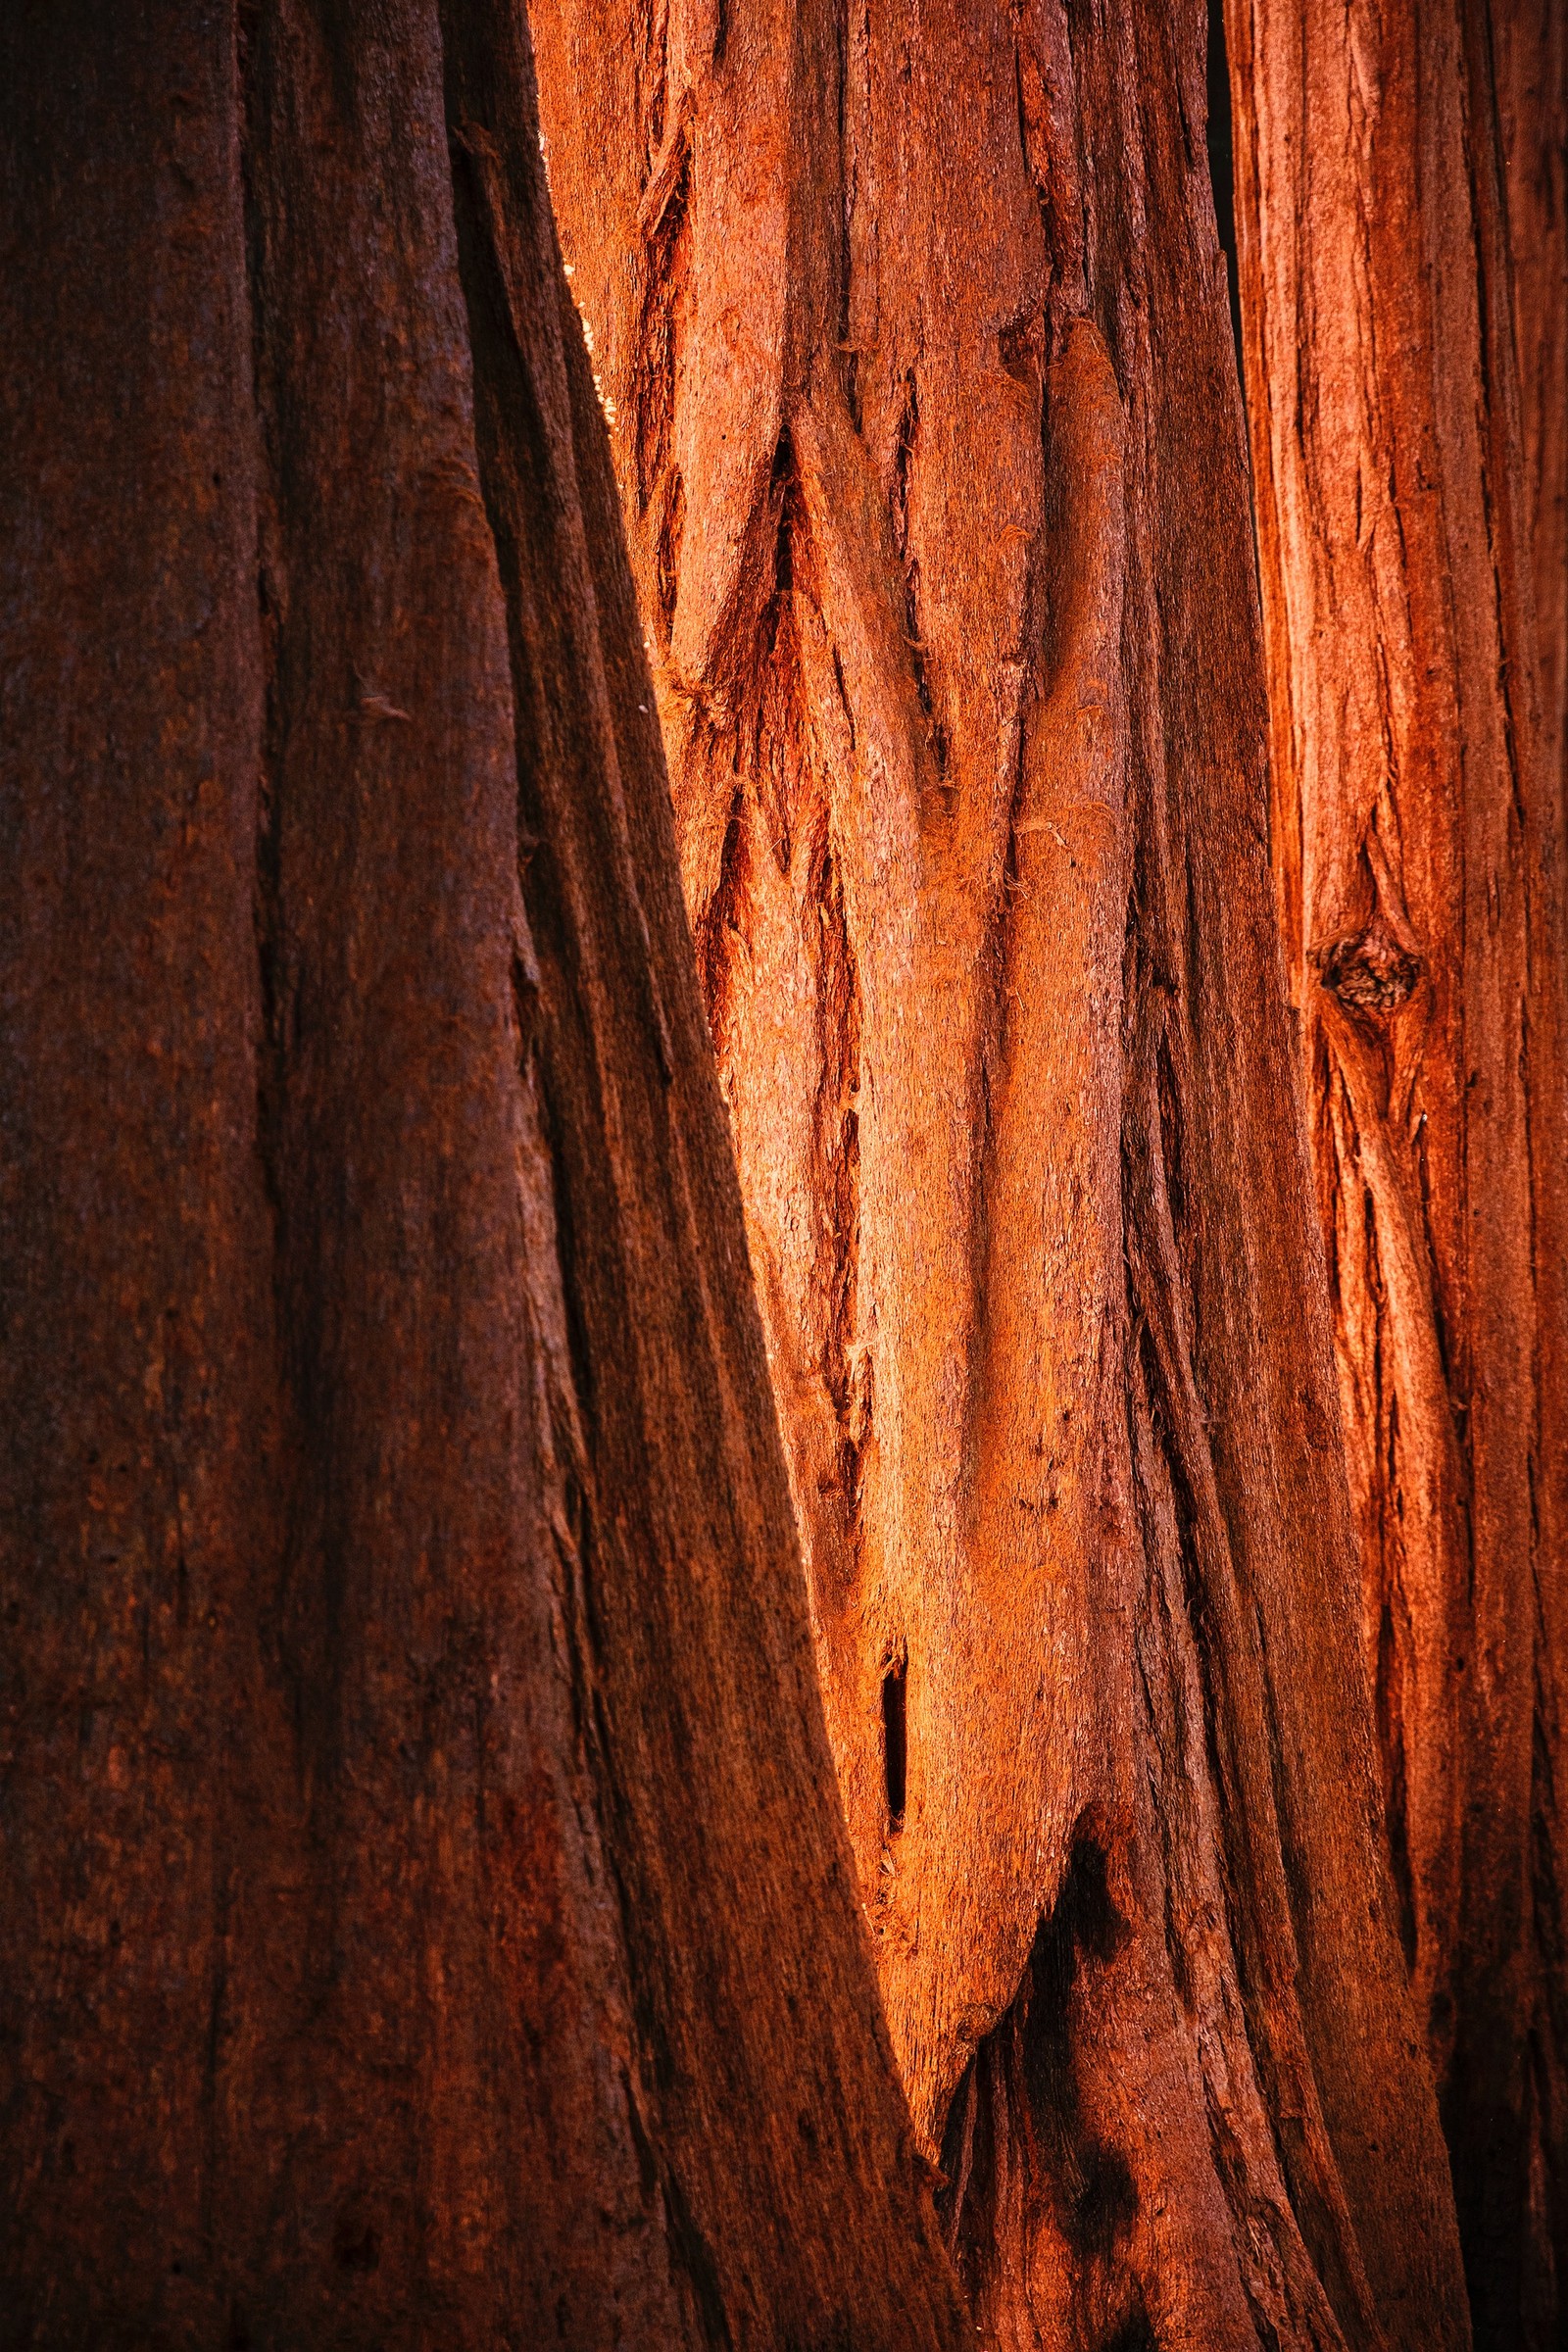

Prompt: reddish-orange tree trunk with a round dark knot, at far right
[{"left": 1230, "top": 0, "right": 1568, "bottom": 2352}]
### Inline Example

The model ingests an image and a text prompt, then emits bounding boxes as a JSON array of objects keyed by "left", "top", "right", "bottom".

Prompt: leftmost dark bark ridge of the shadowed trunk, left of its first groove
[{"left": 0, "top": 10, "right": 272, "bottom": 2340}]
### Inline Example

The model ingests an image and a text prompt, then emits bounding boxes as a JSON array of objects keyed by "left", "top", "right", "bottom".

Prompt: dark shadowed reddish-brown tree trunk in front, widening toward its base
[{"left": 0, "top": 0, "right": 968, "bottom": 2352}]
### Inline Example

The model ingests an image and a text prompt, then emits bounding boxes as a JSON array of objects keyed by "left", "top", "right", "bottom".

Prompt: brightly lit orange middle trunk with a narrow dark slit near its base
[{"left": 534, "top": 0, "right": 1467, "bottom": 2352}]
